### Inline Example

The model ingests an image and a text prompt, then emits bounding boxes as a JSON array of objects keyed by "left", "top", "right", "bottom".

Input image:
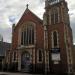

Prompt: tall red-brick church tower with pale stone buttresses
[{"left": 43, "top": 0, "right": 73, "bottom": 73}]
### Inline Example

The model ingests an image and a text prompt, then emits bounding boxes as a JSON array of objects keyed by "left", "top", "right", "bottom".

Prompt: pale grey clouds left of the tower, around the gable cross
[{"left": 0, "top": 0, "right": 43, "bottom": 42}]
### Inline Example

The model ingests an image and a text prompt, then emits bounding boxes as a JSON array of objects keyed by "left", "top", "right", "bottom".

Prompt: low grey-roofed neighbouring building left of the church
[{"left": 0, "top": 35, "right": 11, "bottom": 71}]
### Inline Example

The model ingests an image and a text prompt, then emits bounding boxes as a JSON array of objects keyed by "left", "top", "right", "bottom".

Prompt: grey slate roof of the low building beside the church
[{"left": 0, "top": 41, "right": 11, "bottom": 56}]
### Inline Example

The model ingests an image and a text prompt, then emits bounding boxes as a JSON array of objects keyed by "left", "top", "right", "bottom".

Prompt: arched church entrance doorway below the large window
[{"left": 21, "top": 51, "right": 30, "bottom": 72}]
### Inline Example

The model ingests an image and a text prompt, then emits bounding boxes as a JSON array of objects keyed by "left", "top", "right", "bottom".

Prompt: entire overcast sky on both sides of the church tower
[{"left": 0, "top": 0, "right": 75, "bottom": 43}]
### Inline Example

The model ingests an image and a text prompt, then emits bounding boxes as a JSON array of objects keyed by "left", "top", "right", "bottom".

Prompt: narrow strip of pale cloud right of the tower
[{"left": 66, "top": 0, "right": 75, "bottom": 43}]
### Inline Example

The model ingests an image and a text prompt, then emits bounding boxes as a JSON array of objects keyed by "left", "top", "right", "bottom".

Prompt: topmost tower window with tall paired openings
[{"left": 51, "top": 8, "right": 59, "bottom": 24}]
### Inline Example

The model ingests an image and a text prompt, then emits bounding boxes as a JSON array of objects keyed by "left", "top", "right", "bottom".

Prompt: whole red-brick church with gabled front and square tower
[{"left": 6, "top": 0, "right": 73, "bottom": 74}]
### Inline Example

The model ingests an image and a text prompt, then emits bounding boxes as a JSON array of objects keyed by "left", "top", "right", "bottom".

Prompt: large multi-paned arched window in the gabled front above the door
[{"left": 21, "top": 24, "right": 34, "bottom": 46}]
